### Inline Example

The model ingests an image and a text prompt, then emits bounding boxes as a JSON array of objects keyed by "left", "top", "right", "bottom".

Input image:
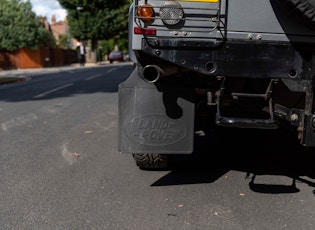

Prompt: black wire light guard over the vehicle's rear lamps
[{"left": 134, "top": 0, "right": 224, "bottom": 38}]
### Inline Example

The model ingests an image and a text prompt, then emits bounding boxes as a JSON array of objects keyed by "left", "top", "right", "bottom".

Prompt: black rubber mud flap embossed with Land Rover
[{"left": 118, "top": 68, "right": 194, "bottom": 154}]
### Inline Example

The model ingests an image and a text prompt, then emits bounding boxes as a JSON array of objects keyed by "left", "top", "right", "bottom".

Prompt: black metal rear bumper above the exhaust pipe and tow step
[{"left": 142, "top": 38, "right": 315, "bottom": 80}]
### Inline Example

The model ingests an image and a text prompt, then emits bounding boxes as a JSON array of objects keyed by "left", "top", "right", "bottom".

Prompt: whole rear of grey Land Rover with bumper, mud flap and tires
[{"left": 118, "top": 0, "right": 315, "bottom": 169}]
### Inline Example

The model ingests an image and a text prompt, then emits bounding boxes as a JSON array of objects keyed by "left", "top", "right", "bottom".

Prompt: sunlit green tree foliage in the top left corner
[{"left": 0, "top": 0, "right": 53, "bottom": 51}]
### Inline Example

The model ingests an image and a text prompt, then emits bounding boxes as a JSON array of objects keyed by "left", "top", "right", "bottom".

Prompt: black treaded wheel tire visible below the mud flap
[{"left": 132, "top": 153, "right": 169, "bottom": 170}]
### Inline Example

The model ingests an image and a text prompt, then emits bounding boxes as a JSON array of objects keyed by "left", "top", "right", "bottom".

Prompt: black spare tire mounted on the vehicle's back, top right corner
[{"left": 278, "top": 0, "right": 315, "bottom": 30}]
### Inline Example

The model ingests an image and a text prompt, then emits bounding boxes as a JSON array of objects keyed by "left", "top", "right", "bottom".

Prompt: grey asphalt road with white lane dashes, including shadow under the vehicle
[{"left": 0, "top": 63, "right": 315, "bottom": 230}]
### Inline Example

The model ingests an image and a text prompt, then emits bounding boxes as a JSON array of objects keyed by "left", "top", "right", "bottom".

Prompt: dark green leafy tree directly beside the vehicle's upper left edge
[{"left": 58, "top": 0, "right": 130, "bottom": 49}]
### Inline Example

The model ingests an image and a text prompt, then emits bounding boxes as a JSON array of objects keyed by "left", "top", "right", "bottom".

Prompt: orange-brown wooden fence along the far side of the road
[{"left": 0, "top": 48, "right": 78, "bottom": 70}]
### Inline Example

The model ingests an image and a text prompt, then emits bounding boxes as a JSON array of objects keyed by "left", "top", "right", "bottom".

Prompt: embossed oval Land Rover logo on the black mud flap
[{"left": 126, "top": 116, "right": 186, "bottom": 146}]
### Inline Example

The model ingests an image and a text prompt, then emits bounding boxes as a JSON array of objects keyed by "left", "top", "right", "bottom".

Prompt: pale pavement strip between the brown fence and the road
[{"left": 0, "top": 62, "right": 108, "bottom": 85}]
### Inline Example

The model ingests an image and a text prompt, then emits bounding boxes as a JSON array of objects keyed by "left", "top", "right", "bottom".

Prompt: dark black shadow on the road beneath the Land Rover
[{"left": 152, "top": 115, "right": 315, "bottom": 194}]
